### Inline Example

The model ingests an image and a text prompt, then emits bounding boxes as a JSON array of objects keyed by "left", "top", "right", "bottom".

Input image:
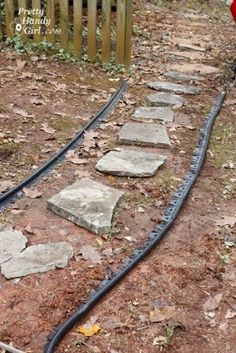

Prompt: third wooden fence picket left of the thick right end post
[{"left": 73, "top": 0, "right": 83, "bottom": 58}]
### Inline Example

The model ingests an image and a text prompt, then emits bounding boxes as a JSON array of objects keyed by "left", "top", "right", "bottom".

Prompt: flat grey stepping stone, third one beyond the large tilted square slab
[{"left": 132, "top": 107, "right": 174, "bottom": 122}]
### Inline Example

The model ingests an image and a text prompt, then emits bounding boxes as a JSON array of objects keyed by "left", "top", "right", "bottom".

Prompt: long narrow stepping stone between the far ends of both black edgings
[{"left": 148, "top": 81, "right": 202, "bottom": 95}]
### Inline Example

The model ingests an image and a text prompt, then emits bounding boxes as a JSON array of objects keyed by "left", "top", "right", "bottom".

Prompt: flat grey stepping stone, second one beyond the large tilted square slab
[{"left": 119, "top": 123, "right": 170, "bottom": 148}]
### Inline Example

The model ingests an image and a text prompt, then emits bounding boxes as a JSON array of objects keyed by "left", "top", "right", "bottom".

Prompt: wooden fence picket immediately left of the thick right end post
[{"left": 102, "top": 0, "right": 111, "bottom": 62}]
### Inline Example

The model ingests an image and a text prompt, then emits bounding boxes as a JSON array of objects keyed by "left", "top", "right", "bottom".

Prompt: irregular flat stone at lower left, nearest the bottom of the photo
[{"left": 1, "top": 242, "right": 73, "bottom": 279}]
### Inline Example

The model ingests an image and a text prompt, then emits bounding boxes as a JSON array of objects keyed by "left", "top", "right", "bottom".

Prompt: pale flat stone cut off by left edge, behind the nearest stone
[{"left": 0, "top": 230, "right": 27, "bottom": 264}]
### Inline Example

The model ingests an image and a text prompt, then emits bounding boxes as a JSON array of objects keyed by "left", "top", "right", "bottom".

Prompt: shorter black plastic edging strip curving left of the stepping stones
[{"left": 0, "top": 80, "right": 128, "bottom": 210}]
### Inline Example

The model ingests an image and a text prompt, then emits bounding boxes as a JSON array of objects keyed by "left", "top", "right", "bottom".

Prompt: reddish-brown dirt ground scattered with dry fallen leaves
[{"left": 0, "top": 1, "right": 236, "bottom": 353}]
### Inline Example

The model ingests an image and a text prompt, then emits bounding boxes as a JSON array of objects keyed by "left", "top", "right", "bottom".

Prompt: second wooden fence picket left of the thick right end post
[{"left": 87, "top": 0, "right": 97, "bottom": 61}]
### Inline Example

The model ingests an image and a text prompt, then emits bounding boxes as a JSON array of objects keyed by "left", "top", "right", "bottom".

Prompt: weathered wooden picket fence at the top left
[{"left": 0, "top": 0, "right": 133, "bottom": 66}]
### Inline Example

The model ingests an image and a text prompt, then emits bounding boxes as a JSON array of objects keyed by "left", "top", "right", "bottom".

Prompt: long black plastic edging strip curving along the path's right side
[{"left": 44, "top": 92, "right": 226, "bottom": 353}]
